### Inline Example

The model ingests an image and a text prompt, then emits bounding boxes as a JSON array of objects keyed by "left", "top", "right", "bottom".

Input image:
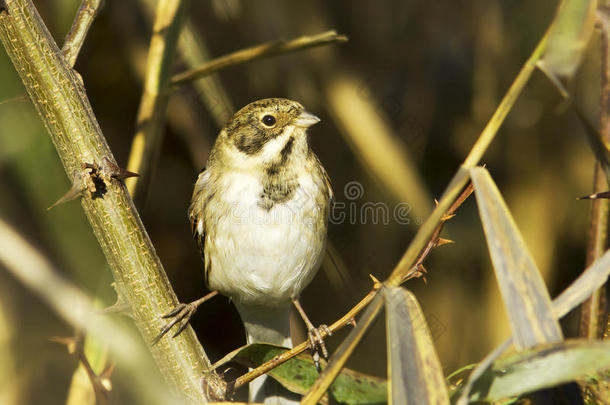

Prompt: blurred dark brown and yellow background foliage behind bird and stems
[{"left": 0, "top": 0, "right": 599, "bottom": 403}]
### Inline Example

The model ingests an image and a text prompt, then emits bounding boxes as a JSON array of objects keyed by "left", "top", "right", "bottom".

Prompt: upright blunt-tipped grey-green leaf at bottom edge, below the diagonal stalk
[{"left": 383, "top": 287, "right": 449, "bottom": 405}]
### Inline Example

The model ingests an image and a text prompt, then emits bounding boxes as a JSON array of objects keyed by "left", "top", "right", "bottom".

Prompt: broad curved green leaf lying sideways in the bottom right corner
[{"left": 469, "top": 340, "right": 610, "bottom": 401}]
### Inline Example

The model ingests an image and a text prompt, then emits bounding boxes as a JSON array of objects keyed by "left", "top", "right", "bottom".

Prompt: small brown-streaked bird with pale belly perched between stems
[{"left": 158, "top": 98, "right": 333, "bottom": 403}]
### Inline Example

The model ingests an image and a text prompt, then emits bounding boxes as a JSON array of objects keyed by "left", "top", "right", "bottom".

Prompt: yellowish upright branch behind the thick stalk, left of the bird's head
[{"left": 126, "top": 0, "right": 186, "bottom": 203}]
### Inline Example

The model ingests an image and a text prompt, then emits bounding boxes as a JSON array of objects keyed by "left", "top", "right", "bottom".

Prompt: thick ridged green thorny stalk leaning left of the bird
[{"left": 0, "top": 0, "right": 214, "bottom": 403}]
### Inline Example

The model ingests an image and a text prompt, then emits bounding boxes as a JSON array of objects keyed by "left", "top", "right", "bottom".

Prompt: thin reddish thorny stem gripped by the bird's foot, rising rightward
[{"left": 229, "top": 184, "right": 474, "bottom": 389}]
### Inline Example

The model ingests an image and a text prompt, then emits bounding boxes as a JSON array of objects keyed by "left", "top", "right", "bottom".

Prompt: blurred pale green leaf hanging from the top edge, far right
[{"left": 539, "top": 0, "right": 597, "bottom": 78}]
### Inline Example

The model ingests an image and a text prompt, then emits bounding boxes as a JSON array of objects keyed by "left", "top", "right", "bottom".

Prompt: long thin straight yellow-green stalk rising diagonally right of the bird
[{"left": 302, "top": 20, "right": 549, "bottom": 404}]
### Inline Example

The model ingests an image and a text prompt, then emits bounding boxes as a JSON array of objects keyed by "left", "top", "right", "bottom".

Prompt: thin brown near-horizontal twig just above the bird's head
[{"left": 171, "top": 31, "right": 347, "bottom": 86}]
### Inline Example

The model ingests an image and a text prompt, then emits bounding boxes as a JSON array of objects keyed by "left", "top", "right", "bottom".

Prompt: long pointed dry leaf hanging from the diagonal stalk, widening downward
[{"left": 470, "top": 167, "right": 563, "bottom": 350}]
